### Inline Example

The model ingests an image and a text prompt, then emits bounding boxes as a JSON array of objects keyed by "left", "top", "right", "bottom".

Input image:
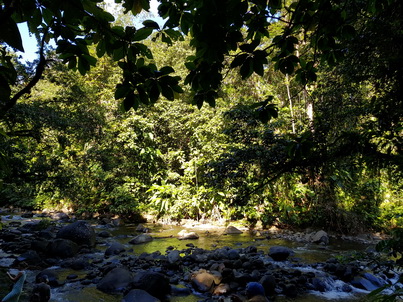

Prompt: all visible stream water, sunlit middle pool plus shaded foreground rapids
[{"left": 0, "top": 215, "right": 398, "bottom": 302}]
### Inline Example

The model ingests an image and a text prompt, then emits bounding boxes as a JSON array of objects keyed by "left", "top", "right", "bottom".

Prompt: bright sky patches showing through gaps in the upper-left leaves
[{"left": 18, "top": 0, "right": 163, "bottom": 62}]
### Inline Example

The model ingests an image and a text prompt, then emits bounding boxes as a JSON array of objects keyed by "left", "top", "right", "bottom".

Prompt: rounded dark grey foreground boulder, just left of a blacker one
[{"left": 97, "top": 267, "right": 133, "bottom": 294}]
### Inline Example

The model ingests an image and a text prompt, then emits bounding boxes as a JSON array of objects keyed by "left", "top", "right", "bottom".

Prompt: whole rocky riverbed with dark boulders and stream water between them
[{"left": 0, "top": 213, "right": 398, "bottom": 302}]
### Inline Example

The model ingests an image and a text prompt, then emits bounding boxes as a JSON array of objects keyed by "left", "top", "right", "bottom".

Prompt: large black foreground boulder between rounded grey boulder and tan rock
[{"left": 133, "top": 272, "right": 171, "bottom": 301}]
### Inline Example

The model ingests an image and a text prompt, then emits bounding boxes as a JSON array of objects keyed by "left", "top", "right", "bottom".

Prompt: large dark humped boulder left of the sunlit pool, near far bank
[{"left": 56, "top": 220, "right": 96, "bottom": 247}]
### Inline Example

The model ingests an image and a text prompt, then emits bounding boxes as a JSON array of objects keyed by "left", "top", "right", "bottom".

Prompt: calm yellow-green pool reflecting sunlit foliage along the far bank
[{"left": 95, "top": 224, "right": 368, "bottom": 263}]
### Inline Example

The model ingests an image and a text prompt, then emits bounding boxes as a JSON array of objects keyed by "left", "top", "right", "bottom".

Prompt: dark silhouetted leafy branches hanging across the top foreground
[{"left": 0, "top": 0, "right": 399, "bottom": 116}]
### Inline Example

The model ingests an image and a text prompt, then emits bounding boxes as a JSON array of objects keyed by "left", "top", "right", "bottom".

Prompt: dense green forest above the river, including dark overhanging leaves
[{"left": 0, "top": 0, "right": 403, "bottom": 232}]
